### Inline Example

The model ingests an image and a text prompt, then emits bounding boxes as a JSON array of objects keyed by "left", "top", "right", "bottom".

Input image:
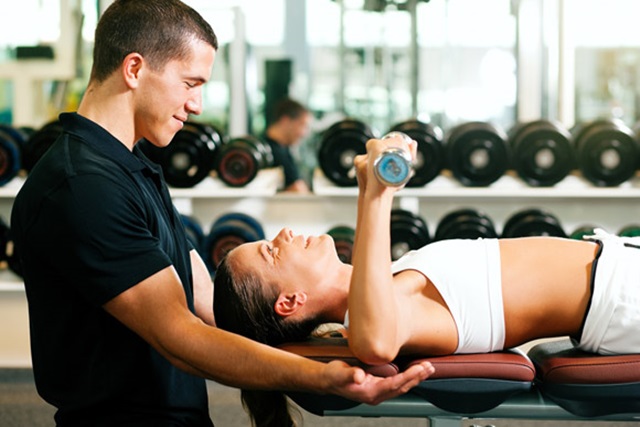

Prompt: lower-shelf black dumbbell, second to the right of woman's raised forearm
[{"left": 435, "top": 208, "right": 498, "bottom": 240}]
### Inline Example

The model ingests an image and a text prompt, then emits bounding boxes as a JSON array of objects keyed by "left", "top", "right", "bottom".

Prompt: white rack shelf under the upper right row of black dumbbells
[{"left": 314, "top": 167, "right": 640, "bottom": 239}]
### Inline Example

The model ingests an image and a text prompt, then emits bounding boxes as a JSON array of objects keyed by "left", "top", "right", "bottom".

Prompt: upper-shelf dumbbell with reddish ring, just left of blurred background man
[{"left": 215, "top": 135, "right": 274, "bottom": 187}]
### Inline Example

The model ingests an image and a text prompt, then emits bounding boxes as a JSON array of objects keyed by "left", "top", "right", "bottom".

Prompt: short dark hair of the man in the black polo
[{"left": 91, "top": 0, "right": 218, "bottom": 82}]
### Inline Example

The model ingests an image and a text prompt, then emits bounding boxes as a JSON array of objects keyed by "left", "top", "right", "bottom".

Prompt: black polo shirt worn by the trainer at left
[{"left": 11, "top": 113, "right": 211, "bottom": 426}]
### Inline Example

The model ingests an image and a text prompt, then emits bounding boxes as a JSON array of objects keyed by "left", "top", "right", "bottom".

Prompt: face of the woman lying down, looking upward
[{"left": 229, "top": 228, "right": 342, "bottom": 291}]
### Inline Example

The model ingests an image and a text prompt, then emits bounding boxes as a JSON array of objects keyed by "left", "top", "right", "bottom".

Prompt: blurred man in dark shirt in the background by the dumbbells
[{"left": 263, "top": 98, "right": 313, "bottom": 193}]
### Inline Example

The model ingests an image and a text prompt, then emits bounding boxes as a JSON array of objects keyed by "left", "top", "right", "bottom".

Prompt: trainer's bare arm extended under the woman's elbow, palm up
[{"left": 104, "top": 267, "right": 433, "bottom": 404}]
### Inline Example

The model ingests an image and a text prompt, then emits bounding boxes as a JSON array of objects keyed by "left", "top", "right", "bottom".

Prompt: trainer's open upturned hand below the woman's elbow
[{"left": 325, "top": 361, "right": 435, "bottom": 405}]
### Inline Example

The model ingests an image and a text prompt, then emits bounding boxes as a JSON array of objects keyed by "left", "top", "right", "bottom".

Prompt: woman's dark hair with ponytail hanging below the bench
[{"left": 213, "top": 255, "right": 319, "bottom": 427}]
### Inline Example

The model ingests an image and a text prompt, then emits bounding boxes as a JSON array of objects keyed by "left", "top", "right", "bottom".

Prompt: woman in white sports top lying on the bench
[{"left": 214, "top": 133, "right": 640, "bottom": 424}]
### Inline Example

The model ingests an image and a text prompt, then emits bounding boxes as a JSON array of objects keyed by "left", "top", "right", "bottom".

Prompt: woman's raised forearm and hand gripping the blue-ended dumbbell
[{"left": 349, "top": 137, "right": 416, "bottom": 364}]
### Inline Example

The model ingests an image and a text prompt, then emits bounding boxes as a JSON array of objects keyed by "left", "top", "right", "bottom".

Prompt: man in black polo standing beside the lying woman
[{"left": 11, "top": 0, "right": 432, "bottom": 427}]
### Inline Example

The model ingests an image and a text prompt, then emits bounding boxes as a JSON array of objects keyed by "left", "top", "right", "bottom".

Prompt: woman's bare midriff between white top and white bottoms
[{"left": 500, "top": 237, "right": 598, "bottom": 347}]
